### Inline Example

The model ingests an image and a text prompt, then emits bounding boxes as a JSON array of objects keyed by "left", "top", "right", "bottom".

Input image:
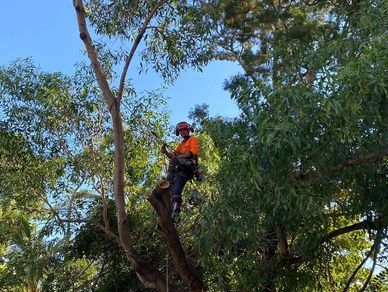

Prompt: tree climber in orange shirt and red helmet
[{"left": 160, "top": 122, "right": 199, "bottom": 223}]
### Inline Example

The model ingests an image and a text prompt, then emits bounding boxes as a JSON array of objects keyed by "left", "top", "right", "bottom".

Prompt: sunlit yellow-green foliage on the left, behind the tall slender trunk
[{"left": 0, "top": 60, "right": 170, "bottom": 291}]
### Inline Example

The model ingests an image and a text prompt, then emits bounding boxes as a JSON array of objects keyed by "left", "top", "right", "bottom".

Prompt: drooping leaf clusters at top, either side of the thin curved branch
[{"left": 85, "top": 0, "right": 212, "bottom": 82}]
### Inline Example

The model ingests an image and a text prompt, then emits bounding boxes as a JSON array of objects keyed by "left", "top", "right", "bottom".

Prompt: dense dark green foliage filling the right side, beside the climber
[{"left": 191, "top": 1, "right": 388, "bottom": 291}]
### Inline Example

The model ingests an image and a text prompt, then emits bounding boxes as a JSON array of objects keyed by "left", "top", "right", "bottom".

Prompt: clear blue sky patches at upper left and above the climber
[{"left": 0, "top": 0, "right": 241, "bottom": 124}]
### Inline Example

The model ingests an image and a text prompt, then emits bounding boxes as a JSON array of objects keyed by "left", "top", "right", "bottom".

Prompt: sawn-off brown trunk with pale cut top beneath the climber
[{"left": 145, "top": 180, "right": 205, "bottom": 291}]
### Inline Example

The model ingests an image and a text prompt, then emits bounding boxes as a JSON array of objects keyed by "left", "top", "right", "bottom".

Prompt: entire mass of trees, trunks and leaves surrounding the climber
[{"left": 0, "top": 0, "right": 388, "bottom": 291}]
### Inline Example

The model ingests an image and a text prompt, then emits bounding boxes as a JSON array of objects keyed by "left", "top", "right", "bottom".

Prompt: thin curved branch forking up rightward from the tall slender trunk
[{"left": 117, "top": 0, "right": 167, "bottom": 104}]
